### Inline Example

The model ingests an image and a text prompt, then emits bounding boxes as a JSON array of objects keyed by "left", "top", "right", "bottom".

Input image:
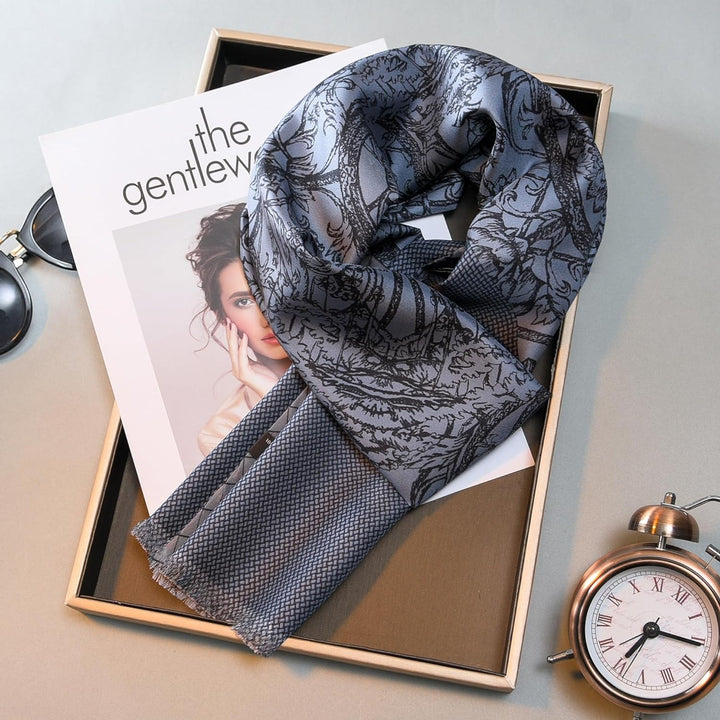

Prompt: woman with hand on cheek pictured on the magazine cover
[{"left": 186, "top": 203, "right": 290, "bottom": 455}]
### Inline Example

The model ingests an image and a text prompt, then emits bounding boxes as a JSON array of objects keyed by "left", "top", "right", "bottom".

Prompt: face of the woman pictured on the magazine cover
[{"left": 218, "top": 260, "right": 287, "bottom": 360}]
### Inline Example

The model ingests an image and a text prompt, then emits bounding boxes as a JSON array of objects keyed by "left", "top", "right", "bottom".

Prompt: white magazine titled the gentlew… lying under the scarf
[{"left": 41, "top": 40, "right": 533, "bottom": 513}]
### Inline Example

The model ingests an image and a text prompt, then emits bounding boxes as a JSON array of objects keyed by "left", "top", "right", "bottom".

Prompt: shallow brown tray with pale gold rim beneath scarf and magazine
[{"left": 66, "top": 30, "right": 612, "bottom": 691}]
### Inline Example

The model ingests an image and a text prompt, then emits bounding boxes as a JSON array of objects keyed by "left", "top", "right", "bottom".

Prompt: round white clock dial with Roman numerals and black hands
[{"left": 583, "top": 564, "right": 720, "bottom": 705}]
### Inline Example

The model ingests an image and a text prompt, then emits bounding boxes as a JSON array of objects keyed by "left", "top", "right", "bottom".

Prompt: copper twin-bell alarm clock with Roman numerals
[{"left": 547, "top": 493, "right": 720, "bottom": 718}]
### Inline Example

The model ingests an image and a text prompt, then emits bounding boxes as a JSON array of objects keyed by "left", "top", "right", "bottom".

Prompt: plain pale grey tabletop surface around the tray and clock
[{"left": 0, "top": 0, "right": 720, "bottom": 720}]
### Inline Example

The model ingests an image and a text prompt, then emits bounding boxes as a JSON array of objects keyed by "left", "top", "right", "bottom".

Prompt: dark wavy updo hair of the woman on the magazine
[{"left": 185, "top": 203, "right": 245, "bottom": 340}]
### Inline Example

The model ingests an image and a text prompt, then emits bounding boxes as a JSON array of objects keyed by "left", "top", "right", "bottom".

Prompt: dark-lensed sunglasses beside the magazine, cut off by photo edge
[{"left": 0, "top": 188, "right": 75, "bottom": 355}]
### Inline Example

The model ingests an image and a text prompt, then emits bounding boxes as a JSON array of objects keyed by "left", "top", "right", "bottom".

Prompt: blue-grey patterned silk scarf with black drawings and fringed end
[{"left": 134, "top": 45, "right": 606, "bottom": 654}]
